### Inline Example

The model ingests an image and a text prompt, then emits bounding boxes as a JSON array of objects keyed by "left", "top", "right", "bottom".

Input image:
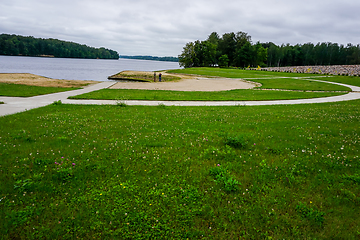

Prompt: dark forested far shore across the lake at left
[{"left": 0, "top": 34, "right": 119, "bottom": 59}]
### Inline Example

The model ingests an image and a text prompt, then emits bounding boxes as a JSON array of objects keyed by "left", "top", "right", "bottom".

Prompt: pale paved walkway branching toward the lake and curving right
[{"left": 0, "top": 79, "right": 360, "bottom": 116}]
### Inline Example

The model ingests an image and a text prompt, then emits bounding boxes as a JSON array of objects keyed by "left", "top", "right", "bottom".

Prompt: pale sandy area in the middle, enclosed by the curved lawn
[{"left": 111, "top": 73, "right": 261, "bottom": 91}]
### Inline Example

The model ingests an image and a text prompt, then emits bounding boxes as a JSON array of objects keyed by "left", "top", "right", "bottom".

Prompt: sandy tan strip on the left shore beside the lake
[{"left": 0, "top": 73, "right": 98, "bottom": 88}]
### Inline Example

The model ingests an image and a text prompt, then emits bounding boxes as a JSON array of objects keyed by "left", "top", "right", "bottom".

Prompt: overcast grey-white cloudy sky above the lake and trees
[{"left": 0, "top": 0, "right": 360, "bottom": 56}]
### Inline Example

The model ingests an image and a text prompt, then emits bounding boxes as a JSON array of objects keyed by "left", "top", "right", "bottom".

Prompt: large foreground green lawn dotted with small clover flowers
[{"left": 0, "top": 100, "right": 360, "bottom": 239}]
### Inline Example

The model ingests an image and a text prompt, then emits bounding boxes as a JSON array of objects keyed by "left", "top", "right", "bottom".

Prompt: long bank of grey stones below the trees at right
[{"left": 261, "top": 65, "right": 360, "bottom": 76}]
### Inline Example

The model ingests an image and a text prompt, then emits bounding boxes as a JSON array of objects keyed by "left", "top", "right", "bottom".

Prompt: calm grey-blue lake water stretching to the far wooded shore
[{"left": 0, "top": 56, "right": 180, "bottom": 81}]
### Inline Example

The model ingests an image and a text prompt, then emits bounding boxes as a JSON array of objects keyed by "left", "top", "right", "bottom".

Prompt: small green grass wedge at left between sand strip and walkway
[{"left": 0, "top": 83, "right": 79, "bottom": 97}]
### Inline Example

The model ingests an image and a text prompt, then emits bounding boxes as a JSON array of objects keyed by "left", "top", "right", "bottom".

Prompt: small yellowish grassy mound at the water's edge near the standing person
[{"left": 108, "top": 71, "right": 181, "bottom": 82}]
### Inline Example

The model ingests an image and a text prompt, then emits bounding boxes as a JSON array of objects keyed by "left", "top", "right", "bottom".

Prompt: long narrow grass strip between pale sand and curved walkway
[{"left": 70, "top": 89, "right": 343, "bottom": 101}]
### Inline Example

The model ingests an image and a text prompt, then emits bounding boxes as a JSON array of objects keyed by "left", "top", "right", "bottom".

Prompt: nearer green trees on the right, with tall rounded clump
[{"left": 179, "top": 32, "right": 360, "bottom": 68}]
